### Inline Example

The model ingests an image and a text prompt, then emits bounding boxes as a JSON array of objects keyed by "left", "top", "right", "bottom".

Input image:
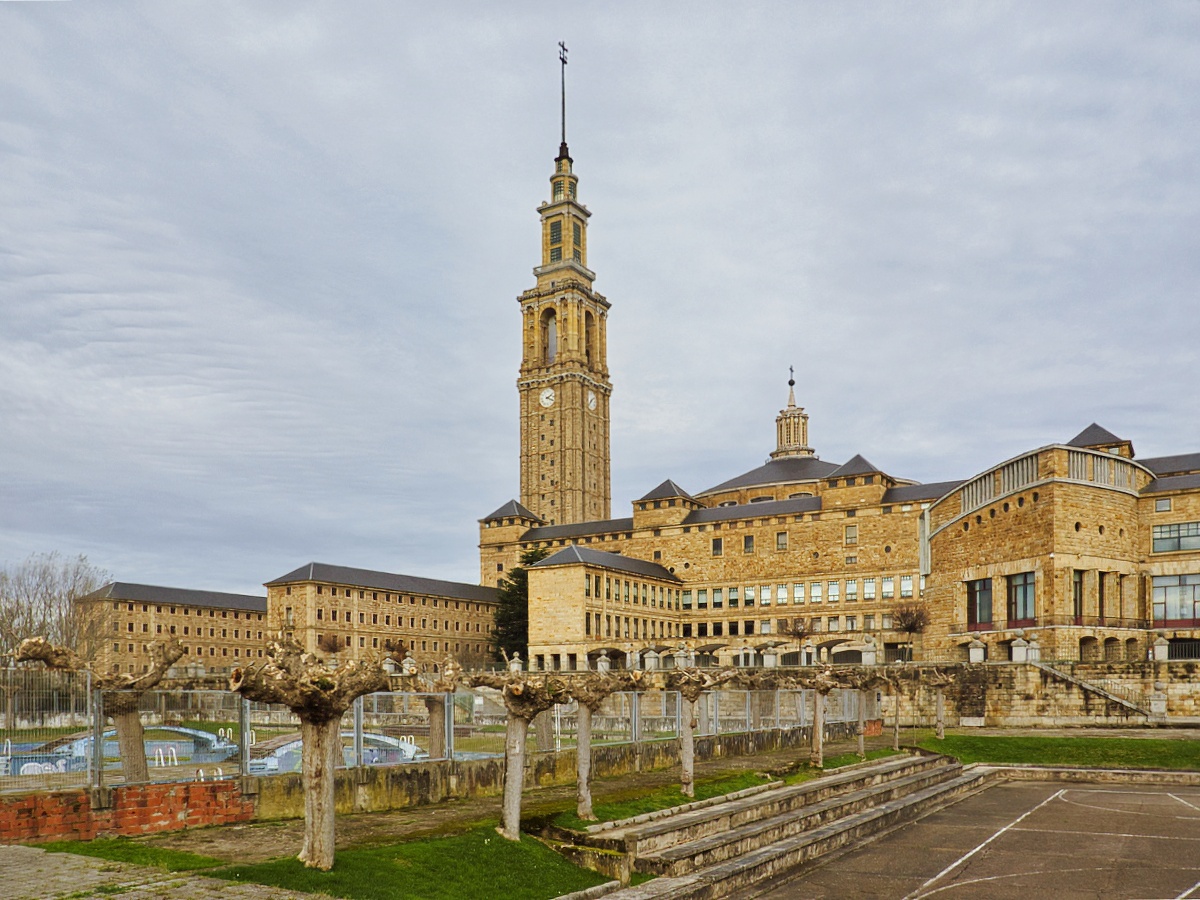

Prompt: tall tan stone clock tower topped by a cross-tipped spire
[{"left": 517, "top": 43, "right": 612, "bottom": 524}]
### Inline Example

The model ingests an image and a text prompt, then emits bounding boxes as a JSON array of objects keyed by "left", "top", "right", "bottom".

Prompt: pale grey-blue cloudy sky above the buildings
[{"left": 0, "top": 0, "right": 1200, "bottom": 593}]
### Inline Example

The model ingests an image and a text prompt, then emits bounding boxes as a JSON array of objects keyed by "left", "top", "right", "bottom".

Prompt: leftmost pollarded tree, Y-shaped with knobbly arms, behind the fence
[{"left": 14, "top": 637, "right": 184, "bottom": 784}]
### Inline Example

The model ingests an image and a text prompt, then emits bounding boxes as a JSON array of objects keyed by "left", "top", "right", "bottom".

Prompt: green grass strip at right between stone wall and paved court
[{"left": 919, "top": 733, "right": 1200, "bottom": 769}]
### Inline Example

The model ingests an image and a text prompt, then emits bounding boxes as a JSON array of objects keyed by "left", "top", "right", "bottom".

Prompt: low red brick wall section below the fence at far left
[{"left": 0, "top": 781, "right": 254, "bottom": 844}]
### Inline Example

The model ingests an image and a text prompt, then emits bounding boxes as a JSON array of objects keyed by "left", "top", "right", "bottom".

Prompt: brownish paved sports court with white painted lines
[{"left": 763, "top": 781, "right": 1200, "bottom": 900}]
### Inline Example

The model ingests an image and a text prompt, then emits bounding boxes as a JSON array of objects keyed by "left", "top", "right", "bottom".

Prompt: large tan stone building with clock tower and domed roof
[{"left": 480, "top": 135, "right": 1200, "bottom": 670}]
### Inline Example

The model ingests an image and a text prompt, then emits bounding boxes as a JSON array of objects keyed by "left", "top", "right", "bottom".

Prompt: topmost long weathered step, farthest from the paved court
[{"left": 577, "top": 755, "right": 946, "bottom": 857}]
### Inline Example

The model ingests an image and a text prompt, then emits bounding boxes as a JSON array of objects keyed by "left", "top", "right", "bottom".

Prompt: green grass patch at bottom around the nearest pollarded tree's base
[{"left": 208, "top": 827, "right": 608, "bottom": 900}]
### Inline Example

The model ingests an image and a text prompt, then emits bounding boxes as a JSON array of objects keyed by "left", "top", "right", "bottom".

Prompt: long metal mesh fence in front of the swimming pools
[{"left": 0, "top": 668, "right": 878, "bottom": 791}]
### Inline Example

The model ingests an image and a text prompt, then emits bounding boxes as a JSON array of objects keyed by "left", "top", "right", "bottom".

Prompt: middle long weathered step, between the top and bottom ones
[{"left": 634, "top": 763, "right": 962, "bottom": 875}]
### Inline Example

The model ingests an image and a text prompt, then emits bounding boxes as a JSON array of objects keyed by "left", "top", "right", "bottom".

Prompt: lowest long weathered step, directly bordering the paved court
[{"left": 607, "top": 770, "right": 988, "bottom": 900}]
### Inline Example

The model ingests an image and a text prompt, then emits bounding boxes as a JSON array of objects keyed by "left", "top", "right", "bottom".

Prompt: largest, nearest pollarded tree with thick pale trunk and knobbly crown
[{"left": 229, "top": 640, "right": 405, "bottom": 871}]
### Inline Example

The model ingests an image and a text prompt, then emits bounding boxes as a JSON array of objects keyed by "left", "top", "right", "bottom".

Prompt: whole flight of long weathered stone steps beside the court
[{"left": 556, "top": 756, "right": 984, "bottom": 900}]
